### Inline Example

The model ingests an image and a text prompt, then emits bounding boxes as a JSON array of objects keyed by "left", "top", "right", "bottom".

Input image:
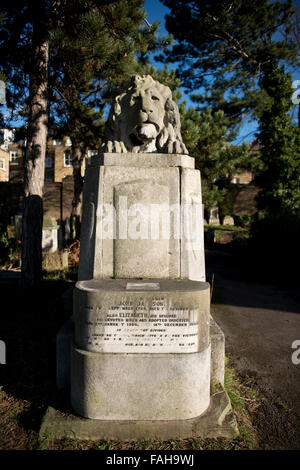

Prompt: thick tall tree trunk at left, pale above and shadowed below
[{"left": 22, "top": 39, "right": 49, "bottom": 287}]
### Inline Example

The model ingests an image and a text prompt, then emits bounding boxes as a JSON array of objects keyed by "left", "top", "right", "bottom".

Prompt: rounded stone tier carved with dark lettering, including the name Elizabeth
[{"left": 74, "top": 279, "right": 210, "bottom": 354}]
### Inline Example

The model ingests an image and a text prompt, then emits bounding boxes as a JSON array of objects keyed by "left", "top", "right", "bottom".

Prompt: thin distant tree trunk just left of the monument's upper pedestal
[{"left": 71, "top": 142, "right": 84, "bottom": 240}]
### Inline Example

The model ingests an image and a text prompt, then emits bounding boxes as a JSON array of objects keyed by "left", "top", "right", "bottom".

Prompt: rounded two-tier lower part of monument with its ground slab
[{"left": 52, "top": 280, "right": 237, "bottom": 440}]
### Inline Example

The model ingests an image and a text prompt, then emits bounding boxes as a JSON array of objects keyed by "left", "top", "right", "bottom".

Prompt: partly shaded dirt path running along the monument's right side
[{"left": 206, "top": 251, "right": 300, "bottom": 449}]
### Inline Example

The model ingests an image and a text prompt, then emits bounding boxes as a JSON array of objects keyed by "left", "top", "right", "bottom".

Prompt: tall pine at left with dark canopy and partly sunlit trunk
[{"left": 0, "top": 0, "right": 161, "bottom": 286}]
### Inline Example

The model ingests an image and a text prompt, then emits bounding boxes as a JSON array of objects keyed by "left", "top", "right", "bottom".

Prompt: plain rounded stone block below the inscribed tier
[{"left": 71, "top": 346, "right": 211, "bottom": 420}]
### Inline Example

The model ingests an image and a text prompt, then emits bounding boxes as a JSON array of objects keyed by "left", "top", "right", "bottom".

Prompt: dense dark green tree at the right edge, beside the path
[{"left": 257, "top": 62, "right": 300, "bottom": 217}]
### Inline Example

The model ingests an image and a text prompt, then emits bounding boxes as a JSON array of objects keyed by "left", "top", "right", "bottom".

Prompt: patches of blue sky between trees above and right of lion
[{"left": 144, "top": 0, "right": 300, "bottom": 144}]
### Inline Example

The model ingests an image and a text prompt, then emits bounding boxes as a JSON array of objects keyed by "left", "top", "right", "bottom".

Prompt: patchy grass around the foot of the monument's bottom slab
[{"left": 0, "top": 348, "right": 260, "bottom": 450}]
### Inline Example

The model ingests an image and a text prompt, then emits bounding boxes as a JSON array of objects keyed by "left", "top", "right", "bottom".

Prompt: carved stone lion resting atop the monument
[{"left": 104, "top": 75, "right": 188, "bottom": 155}]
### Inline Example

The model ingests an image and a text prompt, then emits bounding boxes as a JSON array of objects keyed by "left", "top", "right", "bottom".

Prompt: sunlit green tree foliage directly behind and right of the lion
[{"left": 144, "top": 66, "right": 261, "bottom": 208}]
